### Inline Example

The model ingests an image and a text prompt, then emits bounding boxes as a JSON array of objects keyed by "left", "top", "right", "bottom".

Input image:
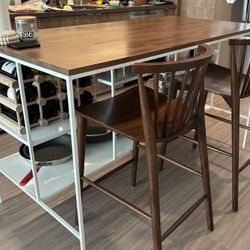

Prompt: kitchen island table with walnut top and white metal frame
[{"left": 0, "top": 17, "right": 250, "bottom": 250}]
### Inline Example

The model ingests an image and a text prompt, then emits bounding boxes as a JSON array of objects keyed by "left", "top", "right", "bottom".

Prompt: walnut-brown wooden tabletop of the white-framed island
[{"left": 0, "top": 16, "right": 250, "bottom": 75}]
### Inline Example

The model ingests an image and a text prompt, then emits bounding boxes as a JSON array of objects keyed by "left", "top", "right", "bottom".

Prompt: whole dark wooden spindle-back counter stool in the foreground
[{"left": 78, "top": 45, "right": 213, "bottom": 250}]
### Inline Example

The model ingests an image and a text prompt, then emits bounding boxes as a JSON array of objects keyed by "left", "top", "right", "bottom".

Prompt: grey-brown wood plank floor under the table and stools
[{"left": 0, "top": 94, "right": 250, "bottom": 250}]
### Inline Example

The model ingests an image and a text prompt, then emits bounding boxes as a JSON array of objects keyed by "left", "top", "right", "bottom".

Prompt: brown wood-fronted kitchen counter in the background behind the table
[{"left": 10, "top": 2, "right": 176, "bottom": 29}]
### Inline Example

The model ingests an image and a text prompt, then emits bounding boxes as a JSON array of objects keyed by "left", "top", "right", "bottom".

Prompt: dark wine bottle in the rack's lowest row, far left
[{"left": 0, "top": 104, "right": 39, "bottom": 126}]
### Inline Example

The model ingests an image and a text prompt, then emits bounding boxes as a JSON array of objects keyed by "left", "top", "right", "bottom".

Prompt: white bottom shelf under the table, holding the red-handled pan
[{"left": 0, "top": 137, "right": 132, "bottom": 200}]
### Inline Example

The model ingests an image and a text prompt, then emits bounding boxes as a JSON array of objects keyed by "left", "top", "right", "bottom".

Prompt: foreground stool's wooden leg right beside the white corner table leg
[{"left": 75, "top": 116, "right": 87, "bottom": 225}]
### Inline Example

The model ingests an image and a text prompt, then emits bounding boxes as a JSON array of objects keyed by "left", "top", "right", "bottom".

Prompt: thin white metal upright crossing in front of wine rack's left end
[{"left": 16, "top": 63, "right": 40, "bottom": 201}]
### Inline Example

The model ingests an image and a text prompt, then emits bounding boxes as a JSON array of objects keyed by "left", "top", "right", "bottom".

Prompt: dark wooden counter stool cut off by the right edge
[{"left": 205, "top": 38, "right": 250, "bottom": 211}]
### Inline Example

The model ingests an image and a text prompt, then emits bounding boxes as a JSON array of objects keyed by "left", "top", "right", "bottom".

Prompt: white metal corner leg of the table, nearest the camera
[{"left": 66, "top": 77, "right": 85, "bottom": 250}]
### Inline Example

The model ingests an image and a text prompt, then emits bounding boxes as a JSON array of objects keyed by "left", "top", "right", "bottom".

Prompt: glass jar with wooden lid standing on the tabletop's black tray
[{"left": 15, "top": 16, "right": 38, "bottom": 41}]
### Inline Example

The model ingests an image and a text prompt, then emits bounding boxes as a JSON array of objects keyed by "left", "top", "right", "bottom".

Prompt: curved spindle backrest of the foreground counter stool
[{"left": 133, "top": 45, "right": 213, "bottom": 142}]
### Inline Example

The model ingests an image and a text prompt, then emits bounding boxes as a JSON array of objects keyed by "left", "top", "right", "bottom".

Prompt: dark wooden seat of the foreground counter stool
[{"left": 77, "top": 86, "right": 174, "bottom": 142}]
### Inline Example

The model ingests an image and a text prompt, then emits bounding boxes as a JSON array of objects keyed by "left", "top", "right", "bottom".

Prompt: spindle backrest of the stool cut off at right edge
[{"left": 229, "top": 37, "right": 250, "bottom": 98}]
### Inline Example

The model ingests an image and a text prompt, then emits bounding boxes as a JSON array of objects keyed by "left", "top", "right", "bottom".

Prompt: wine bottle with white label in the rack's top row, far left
[{"left": 0, "top": 59, "right": 34, "bottom": 80}]
